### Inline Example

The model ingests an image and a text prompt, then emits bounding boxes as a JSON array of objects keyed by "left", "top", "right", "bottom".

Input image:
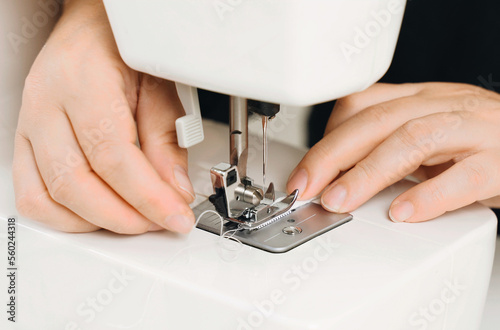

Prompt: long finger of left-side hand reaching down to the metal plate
[{"left": 66, "top": 73, "right": 194, "bottom": 233}]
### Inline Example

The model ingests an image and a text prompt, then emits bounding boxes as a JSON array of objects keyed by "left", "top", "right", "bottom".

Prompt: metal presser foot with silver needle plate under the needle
[{"left": 193, "top": 163, "right": 352, "bottom": 253}]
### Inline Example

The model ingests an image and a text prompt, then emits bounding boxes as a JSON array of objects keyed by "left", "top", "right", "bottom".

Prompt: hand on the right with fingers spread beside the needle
[{"left": 287, "top": 83, "right": 500, "bottom": 222}]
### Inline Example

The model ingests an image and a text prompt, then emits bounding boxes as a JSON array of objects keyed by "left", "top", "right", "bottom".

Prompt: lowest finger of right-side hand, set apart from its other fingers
[{"left": 389, "top": 151, "right": 500, "bottom": 222}]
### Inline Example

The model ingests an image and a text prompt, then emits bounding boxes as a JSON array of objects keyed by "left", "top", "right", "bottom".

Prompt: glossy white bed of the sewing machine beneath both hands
[{"left": 0, "top": 122, "right": 496, "bottom": 330}]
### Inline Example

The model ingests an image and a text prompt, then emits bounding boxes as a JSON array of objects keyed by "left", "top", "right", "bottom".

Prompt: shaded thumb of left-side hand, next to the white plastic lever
[{"left": 137, "top": 75, "right": 195, "bottom": 203}]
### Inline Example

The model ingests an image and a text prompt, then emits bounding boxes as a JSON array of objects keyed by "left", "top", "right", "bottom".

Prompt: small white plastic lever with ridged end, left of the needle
[{"left": 175, "top": 82, "right": 204, "bottom": 148}]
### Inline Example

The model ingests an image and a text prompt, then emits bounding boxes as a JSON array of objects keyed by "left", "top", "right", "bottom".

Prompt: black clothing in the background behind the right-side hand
[{"left": 309, "top": 0, "right": 500, "bottom": 146}]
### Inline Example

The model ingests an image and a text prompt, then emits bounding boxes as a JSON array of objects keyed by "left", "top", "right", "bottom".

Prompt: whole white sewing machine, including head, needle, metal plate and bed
[{"left": 0, "top": 0, "right": 496, "bottom": 330}]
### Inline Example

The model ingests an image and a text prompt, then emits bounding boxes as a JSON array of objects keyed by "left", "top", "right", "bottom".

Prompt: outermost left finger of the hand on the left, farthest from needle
[{"left": 12, "top": 133, "right": 100, "bottom": 233}]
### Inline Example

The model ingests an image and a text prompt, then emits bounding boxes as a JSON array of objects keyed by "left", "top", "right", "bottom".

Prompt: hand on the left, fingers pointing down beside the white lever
[{"left": 13, "top": 0, "right": 194, "bottom": 234}]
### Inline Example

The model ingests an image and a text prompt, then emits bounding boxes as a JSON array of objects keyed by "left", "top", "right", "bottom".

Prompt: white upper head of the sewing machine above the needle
[{"left": 104, "top": 0, "right": 406, "bottom": 106}]
